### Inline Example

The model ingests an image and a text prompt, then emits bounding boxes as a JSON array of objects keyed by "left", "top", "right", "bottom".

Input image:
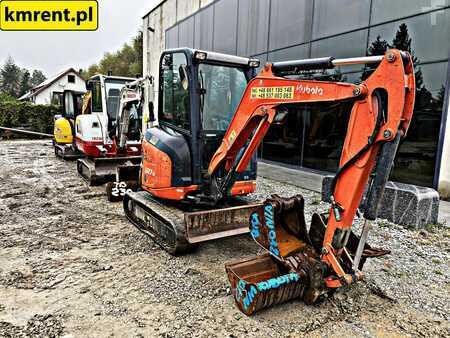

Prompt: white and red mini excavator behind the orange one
[{"left": 75, "top": 75, "right": 152, "bottom": 190}]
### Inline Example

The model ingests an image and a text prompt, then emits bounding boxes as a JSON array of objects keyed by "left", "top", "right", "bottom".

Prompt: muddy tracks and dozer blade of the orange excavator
[{"left": 123, "top": 191, "right": 261, "bottom": 255}]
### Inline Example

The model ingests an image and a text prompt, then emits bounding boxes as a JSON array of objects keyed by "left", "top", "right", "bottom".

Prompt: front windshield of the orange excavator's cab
[{"left": 199, "top": 63, "right": 247, "bottom": 131}]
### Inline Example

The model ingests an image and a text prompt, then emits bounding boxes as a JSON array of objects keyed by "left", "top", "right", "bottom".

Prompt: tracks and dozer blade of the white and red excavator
[{"left": 77, "top": 156, "right": 142, "bottom": 186}]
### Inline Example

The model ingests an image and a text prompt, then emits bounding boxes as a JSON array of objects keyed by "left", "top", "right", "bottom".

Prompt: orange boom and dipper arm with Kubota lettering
[{"left": 218, "top": 49, "right": 415, "bottom": 300}]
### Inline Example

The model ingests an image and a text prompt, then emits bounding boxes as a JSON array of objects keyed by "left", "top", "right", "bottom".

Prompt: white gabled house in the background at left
[{"left": 19, "top": 68, "right": 86, "bottom": 105}]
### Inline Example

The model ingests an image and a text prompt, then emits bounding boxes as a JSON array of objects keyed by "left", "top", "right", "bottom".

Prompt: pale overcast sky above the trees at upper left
[{"left": 0, "top": 0, "right": 158, "bottom": 77}]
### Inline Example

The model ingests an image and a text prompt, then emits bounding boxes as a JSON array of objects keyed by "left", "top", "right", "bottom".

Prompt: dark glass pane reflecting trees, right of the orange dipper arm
[{"left": 391, "top": 62, "right": 447, "bottom": 187}]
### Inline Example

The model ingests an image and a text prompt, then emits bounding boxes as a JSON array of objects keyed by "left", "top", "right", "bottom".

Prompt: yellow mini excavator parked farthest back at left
[{"left": 53, "top": 90, "right": 85, "bottom": 160}]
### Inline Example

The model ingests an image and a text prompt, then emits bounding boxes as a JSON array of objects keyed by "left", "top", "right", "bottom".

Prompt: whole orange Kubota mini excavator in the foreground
[{"left": 123, "top": 48, "right": 415, "bottom": 272}]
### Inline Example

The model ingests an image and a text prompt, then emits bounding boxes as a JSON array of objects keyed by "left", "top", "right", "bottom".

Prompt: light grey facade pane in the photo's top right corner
[{"left": 372, "top": 0, "right": 450, "bottom": 24}]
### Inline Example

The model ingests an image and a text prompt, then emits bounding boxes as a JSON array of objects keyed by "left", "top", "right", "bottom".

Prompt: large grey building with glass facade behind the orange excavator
[{"left": 165, "top": 0, "right": 450, "bottom": 187}]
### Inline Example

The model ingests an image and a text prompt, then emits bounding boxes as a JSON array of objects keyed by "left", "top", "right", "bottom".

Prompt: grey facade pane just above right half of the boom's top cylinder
[{"left": 311, "top": 29, "right": 367, "bottom": 71}]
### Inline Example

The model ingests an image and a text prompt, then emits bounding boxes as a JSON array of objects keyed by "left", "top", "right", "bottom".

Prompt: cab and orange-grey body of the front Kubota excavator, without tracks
[{"left": 141, "top": 48, "right": 259, "bottom": 201}]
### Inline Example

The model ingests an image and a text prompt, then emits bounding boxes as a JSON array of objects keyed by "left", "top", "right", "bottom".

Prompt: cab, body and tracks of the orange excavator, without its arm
[{"left": 123, "top": 48, "right": 259, "bottom": 254}]
